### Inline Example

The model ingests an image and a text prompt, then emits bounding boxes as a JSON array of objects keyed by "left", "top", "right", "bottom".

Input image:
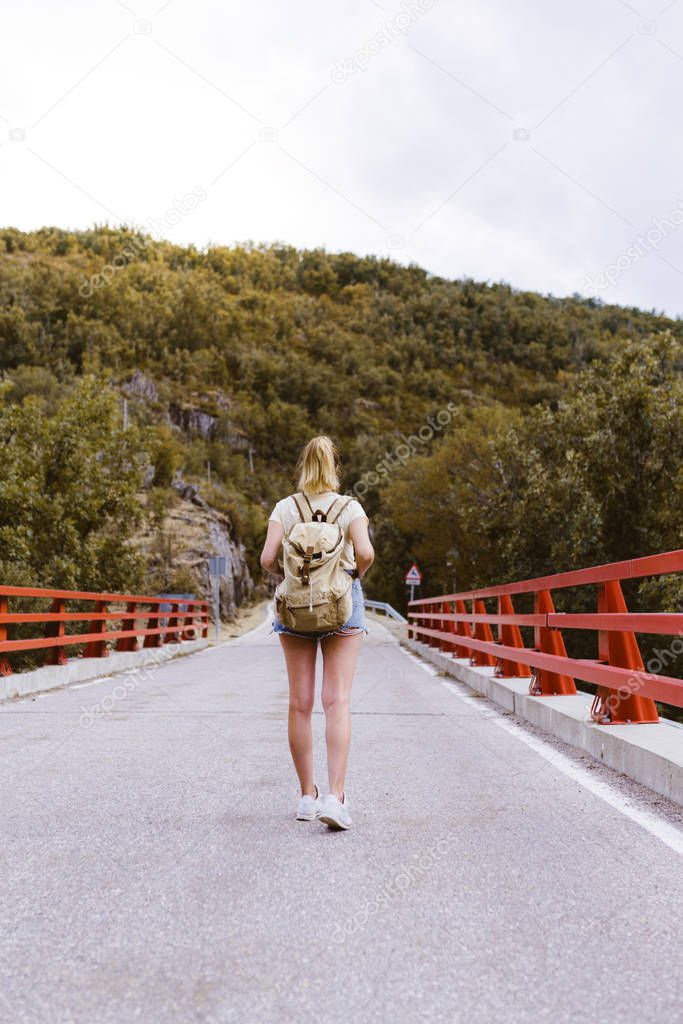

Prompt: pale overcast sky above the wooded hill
[{"left": 0, "top": 0, "right": 683, "bottom": 315}]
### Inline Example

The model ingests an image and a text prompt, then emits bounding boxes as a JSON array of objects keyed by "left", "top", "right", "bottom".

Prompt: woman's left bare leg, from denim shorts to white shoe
[{"left": 280, "top": 633, "right": 317, "bottom": 797}]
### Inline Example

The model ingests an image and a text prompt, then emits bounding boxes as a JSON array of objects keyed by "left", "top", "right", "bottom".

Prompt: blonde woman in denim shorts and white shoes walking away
[{"left": 261, "top": 435, "right": 375, "bottom": 828}]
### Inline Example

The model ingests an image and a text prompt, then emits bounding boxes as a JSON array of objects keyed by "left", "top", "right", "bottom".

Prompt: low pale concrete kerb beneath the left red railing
[{"left": 0, "top": 639, "right": 209, "bottom": 700}]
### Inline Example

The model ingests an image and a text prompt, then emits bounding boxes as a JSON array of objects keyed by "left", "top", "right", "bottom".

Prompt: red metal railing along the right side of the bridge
[{"left": 409, "top": 550, "right": 683, "bottom": 725}]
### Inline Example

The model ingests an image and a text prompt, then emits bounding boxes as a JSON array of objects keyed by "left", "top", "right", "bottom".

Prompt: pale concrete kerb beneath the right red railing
[{"left": 399, "top": 628, "right": 683, "bottom": 805}]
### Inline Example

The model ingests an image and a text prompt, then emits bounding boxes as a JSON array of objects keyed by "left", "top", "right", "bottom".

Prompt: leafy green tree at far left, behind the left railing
[{"left": 0, "top": 378, "right": 146, "bottom": 591}]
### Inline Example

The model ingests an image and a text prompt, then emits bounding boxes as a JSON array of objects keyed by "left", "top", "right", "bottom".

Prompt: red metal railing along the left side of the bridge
[{"left": 0, "top": 587, "right": 209, "bottom": 676}]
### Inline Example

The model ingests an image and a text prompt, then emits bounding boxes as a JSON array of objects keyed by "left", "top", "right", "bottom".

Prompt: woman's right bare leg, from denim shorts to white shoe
[{"left": 321, "top": 633, "right": 362, "bottom": 800}]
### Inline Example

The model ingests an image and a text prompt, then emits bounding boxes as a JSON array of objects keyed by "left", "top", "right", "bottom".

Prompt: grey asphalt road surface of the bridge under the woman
[{"left": 0, "top": 610, "right": 683, "bottom": 1024}]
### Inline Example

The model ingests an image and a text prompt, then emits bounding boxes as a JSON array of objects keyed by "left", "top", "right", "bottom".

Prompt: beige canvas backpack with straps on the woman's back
[{"left": 275, "top": 494, "right": 352, "bottom": 633}]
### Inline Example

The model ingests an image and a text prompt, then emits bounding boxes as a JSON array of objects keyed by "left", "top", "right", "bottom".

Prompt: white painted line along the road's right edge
[{"left": 403, "top": 649, "right": 683, "bottom": 854}]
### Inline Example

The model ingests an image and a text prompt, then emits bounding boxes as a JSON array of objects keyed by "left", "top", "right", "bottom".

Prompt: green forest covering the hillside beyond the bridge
[{"left": 0, "top": 226, "right": 683, "bottom": 610}]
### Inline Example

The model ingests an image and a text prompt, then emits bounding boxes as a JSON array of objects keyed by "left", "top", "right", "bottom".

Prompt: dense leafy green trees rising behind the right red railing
[{"left": 379, "top": 332, "right": 683, "bottom": 610}]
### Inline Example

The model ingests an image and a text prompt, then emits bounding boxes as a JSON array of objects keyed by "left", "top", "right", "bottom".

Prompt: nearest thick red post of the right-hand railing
[{"left": 591, "top": 580, "right": 659, "bottom": 725}]
